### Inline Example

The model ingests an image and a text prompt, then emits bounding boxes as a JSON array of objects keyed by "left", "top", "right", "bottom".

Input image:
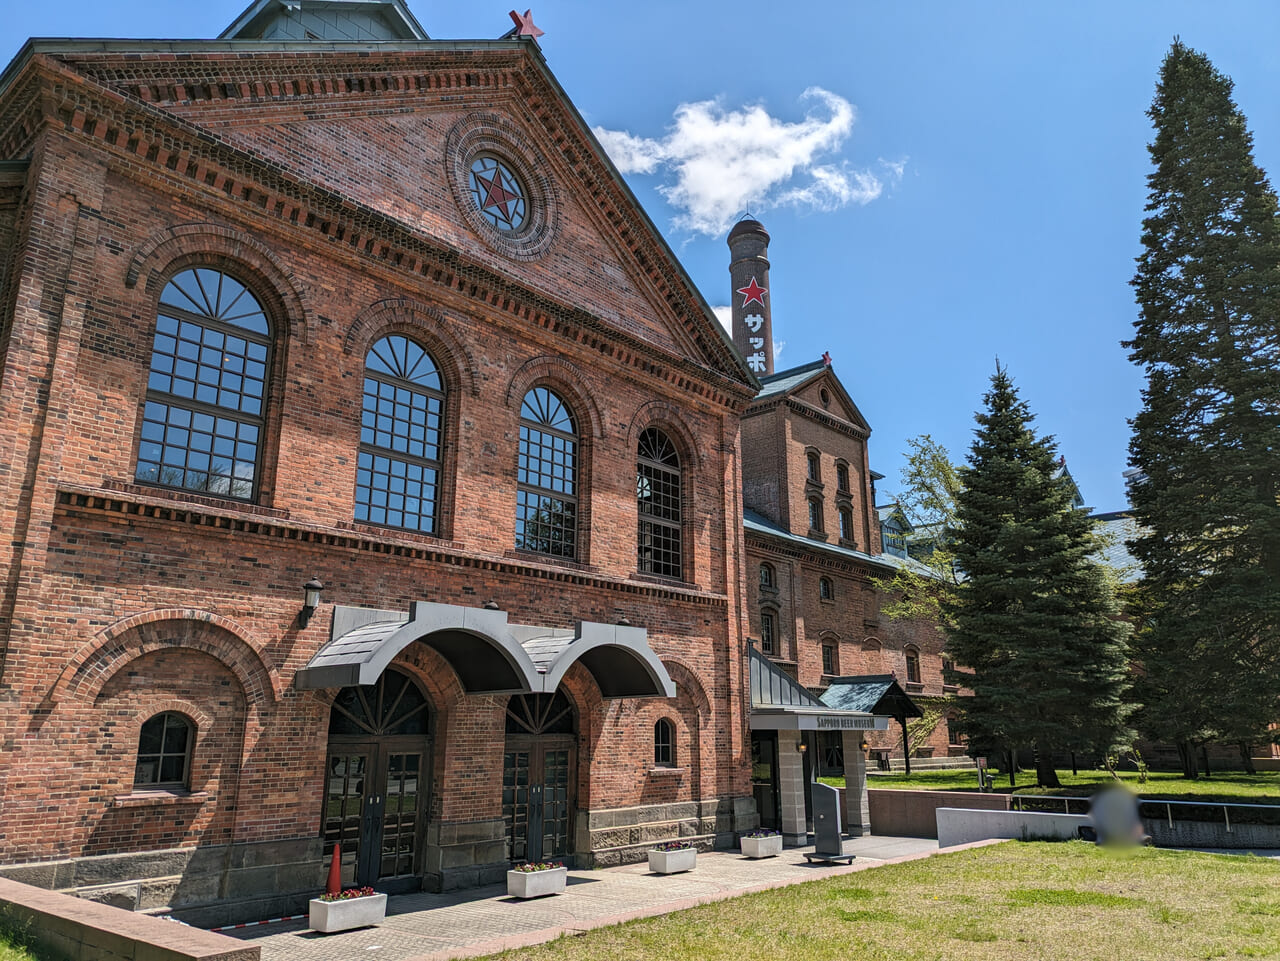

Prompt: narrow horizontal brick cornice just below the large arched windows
[{"left": 58, "top": 484, "right": 728, "bottom": 608}]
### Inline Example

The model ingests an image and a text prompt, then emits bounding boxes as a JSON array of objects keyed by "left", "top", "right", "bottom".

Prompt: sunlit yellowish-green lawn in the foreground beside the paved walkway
[{"left": 483, "top": 842, "right": 1280, "bottom": 961}]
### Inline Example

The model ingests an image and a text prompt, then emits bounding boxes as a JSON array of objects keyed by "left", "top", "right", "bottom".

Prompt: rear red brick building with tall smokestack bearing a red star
[{"left": 728, "top": 220, "right": 965, "bottom": 830}]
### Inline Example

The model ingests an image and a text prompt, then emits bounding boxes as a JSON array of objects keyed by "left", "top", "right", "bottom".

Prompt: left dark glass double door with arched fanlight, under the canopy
[{"left": 323, "top": 671, "right": 430, "bottom": 892}]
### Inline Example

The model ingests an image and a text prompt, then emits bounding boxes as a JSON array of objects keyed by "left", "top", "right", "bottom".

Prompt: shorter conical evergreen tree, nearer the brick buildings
[{"left": 943, "top": 365, "right": 1132, "bottom": 787}]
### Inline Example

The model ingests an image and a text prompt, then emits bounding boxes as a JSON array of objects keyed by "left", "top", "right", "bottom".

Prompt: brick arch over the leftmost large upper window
[{"left": 124, "top": 224, "right": 316, "bottom": 344}]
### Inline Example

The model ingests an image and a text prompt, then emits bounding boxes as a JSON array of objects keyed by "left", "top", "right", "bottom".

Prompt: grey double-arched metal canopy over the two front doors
[{"left": 293, "top": 601, "right": 676, "bottom": 697}]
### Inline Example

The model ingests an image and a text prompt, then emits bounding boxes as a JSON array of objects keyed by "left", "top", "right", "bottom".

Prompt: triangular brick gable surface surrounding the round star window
[{"left": 45, "top": 41, "right": 759, "bottom": 394}]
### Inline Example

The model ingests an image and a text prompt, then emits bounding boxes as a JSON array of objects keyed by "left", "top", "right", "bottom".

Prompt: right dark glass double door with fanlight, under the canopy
[{"left": 502, "top": 694, "right": 577, "bottom": 861}]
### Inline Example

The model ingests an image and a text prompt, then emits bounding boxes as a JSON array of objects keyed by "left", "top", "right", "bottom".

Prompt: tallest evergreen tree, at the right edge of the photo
[{"left": 1125, "top": 40, "right": 1280, "bottom": 777}]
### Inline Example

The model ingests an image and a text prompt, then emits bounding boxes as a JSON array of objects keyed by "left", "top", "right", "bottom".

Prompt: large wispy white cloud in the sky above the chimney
[{"left": 595, "top": 87, "right": 885, "bottom": 237}]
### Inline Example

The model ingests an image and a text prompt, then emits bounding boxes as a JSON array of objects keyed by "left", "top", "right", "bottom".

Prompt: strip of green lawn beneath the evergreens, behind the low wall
[{"left": 822, "top": 769, "right": 1280, "bottom": 804}]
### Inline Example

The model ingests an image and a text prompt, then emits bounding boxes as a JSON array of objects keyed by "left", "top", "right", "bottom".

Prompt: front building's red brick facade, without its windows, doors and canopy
[{"left": 0, "top": 40, "right": 757, "bottom": 920}]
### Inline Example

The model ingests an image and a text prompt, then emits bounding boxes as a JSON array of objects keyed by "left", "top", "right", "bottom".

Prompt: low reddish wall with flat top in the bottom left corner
[{"left": 0, "top": 878, "right": 262, "bottom": 961}]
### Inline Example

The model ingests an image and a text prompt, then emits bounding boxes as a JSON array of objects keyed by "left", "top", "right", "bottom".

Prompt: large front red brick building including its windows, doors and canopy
[{"left": 0, "top": 0, "right": 768, "bottom": 921}]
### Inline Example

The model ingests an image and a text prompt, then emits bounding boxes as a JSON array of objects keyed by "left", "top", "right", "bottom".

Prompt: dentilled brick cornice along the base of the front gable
[{"left": 0, "top": 54, "right": 754, "bottom": 412}]
